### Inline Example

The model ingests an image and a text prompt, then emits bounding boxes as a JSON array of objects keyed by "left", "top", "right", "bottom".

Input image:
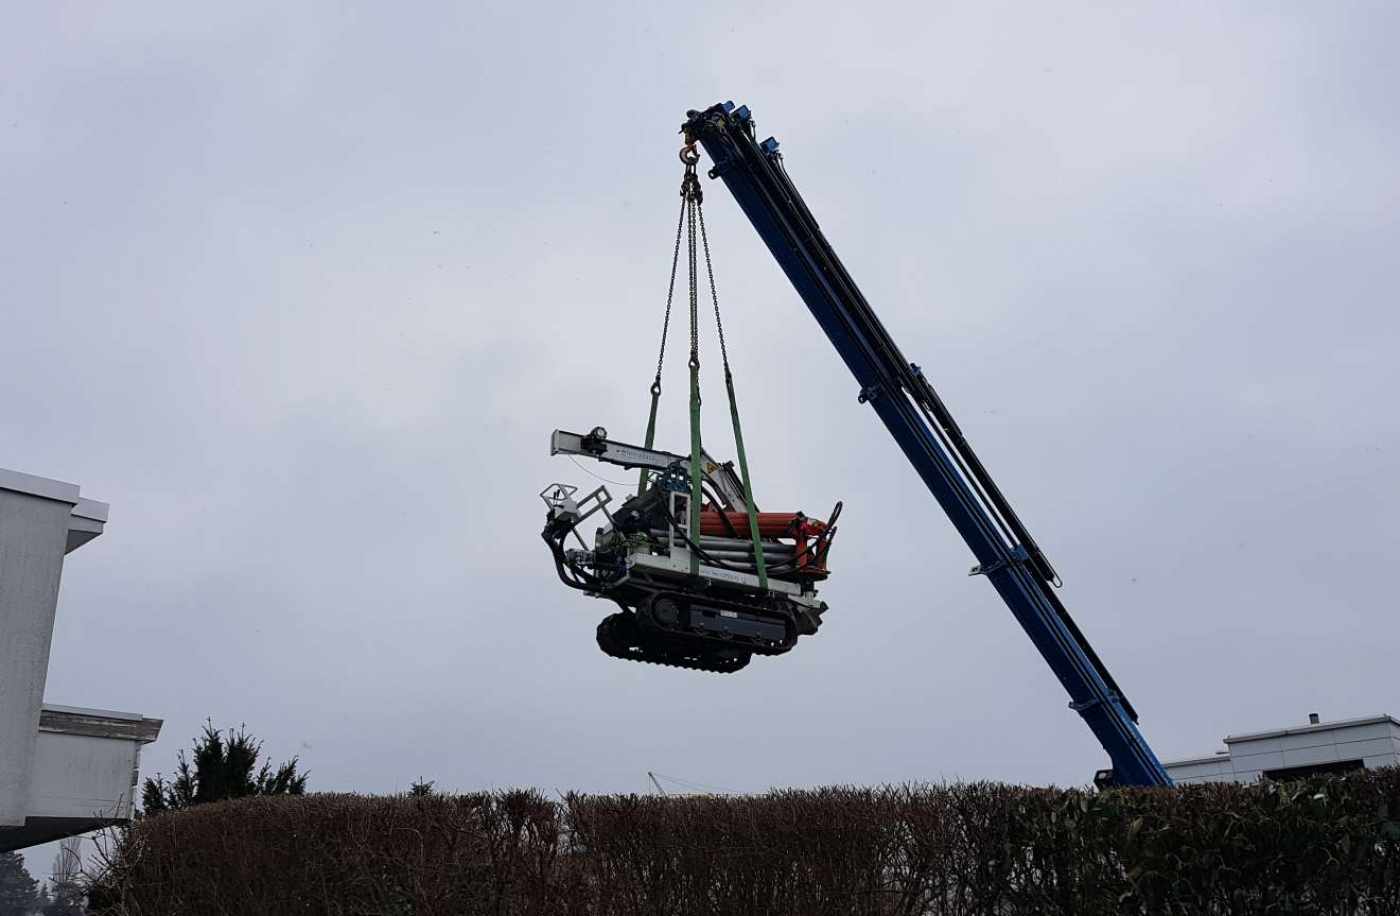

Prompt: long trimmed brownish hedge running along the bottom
[{"left": 92, "top": 769, "right": 1400, "bottom": 916}]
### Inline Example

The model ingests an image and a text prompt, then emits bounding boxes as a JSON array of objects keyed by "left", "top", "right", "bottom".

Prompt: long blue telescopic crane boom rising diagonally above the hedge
[{"left": 682, "top": 102, "right": 1172, "bottom": 786}]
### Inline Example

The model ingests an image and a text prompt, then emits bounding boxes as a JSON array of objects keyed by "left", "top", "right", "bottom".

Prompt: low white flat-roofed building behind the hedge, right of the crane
[{"left": 1163, "top": 713, "right": 1400, "bottom": 786}]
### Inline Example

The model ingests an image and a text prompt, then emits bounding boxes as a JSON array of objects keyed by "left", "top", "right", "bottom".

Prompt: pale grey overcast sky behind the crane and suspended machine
[{"left": 0, "top": 3, "right": 1400, "bottom": 873}]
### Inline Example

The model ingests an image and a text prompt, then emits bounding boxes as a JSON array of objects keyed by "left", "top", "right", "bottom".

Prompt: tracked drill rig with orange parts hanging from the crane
[{"left": 540, "top": 427, "right": 840, "bottom": 674}]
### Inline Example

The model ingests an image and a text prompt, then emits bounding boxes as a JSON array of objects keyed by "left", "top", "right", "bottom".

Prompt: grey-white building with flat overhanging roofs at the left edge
[{"left": 0, "top": 468, "right": 161, "bottom": 852}]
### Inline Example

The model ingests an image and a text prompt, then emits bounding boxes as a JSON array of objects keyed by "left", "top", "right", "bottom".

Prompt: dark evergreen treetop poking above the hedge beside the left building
[{"left": 141, "top": 721, "right": 308, "bottom": 814}]
